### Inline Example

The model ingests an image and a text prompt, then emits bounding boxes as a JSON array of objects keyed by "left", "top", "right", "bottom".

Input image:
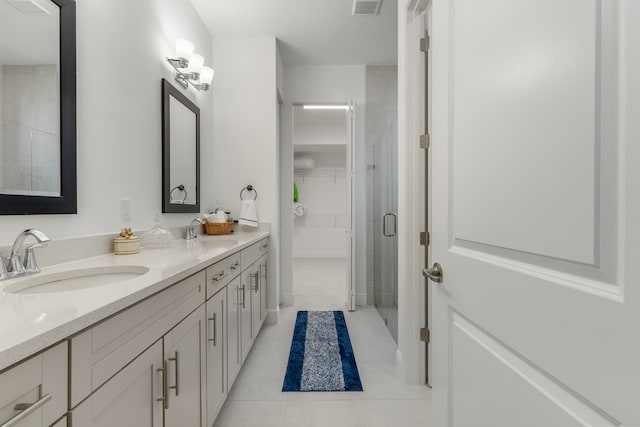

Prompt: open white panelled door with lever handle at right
[{"left": 429, "top": 0, "right": 640, "bottom": 427}]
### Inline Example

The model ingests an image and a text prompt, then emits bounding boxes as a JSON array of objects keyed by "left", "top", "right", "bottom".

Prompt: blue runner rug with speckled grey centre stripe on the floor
[{"left": 282, "top": 311, "right": 362, "bottom": 391}]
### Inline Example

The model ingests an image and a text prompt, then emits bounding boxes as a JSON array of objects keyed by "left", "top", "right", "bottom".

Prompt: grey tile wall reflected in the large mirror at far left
[{"left": 0, "top": 64, "right": 60, "bottom": 195}]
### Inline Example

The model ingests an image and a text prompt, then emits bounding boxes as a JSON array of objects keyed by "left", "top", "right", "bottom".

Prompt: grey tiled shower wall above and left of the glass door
[{"left": 365, "top": 65, "right": 398, "bottom": 304}]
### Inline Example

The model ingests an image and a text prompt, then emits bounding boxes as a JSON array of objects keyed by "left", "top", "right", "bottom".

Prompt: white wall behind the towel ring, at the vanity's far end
[{"left": 212, "top": 37, "right": 280, "bottom": 321}]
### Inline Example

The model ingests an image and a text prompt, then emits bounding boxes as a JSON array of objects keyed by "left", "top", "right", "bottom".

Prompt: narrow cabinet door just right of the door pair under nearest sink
[{"left": 207, "top": 289, "right": 227, "bottom": 426}]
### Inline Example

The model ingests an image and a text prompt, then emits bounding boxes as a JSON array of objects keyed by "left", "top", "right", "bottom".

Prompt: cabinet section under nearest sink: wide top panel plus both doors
[{"left": 70, "top": 271, "right": 205, "bottom": 427}]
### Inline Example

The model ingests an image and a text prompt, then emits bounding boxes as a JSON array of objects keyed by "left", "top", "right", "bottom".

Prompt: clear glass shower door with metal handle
[{"left": 373, "top": 122, "right": 398, "bottom": 342}]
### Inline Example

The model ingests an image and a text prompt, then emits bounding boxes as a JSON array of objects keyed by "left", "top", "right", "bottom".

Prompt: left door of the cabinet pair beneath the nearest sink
[{"left": 71, "top": 340, "right": 163, "bottom": 427}]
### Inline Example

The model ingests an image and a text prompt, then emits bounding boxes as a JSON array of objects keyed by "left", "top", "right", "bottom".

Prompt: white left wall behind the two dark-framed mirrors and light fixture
[{"left": 0, "top": 0, "right": 215, "bottom": 245}]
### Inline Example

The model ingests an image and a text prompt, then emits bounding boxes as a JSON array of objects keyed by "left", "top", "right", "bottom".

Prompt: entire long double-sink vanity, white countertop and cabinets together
[{"left": 0, "top": 231, "right": 269, "bottom": 427}]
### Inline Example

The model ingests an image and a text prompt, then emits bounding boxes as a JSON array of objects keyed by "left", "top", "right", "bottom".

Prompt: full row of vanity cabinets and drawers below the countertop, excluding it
[{"left": 0, "top": 234, "right": 268, "bottom": 427}]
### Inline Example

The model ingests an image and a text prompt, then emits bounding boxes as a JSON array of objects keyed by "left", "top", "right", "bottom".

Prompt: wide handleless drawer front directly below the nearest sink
[{"left": 71, "top": 271, "right": 206, "bottom": 408}]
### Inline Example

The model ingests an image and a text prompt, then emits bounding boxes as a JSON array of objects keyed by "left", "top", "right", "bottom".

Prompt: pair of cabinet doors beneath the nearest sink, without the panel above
[{"left": 72, "top": 300, "right": 205, "bottom": 427}]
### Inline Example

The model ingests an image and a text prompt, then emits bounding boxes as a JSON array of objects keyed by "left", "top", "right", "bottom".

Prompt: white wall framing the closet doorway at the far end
[{"left": 280, "top": 65, "right": 366, "bottom": 305}]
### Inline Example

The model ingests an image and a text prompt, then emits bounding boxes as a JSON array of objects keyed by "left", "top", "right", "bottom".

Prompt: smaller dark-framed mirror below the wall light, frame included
[{"left": 162, "top": 79, "right": 200, "bottom": 213}]
